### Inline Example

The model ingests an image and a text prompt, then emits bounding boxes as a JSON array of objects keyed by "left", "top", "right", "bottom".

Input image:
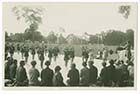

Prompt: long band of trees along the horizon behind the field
[{"left": 5, "top": 28, "right": 134, "bottom": 46}]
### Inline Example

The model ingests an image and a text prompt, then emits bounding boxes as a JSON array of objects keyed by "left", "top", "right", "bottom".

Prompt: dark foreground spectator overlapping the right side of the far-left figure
[{"left": 9, "top": 59, "right": 17, "bottom": 81}]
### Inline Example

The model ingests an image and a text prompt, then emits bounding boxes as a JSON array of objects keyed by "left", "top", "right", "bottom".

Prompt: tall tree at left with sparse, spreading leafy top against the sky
[{"left": 12, "top": 6, "right": 43, "bottom": 42}]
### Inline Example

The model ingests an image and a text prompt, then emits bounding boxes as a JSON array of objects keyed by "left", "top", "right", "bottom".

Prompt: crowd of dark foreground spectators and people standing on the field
[{"left": 5, "top": 41, "right": 134, "bottom": 87}]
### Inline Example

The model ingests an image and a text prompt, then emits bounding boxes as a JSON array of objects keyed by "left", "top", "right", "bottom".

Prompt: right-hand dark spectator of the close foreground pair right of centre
[{"left": 88, "top": 61, "right": 98, "bottom": 85}]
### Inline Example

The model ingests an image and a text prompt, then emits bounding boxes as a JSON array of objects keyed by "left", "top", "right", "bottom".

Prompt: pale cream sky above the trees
[{"left": 3, "top": 2, "right": 138, "bottom": 36}]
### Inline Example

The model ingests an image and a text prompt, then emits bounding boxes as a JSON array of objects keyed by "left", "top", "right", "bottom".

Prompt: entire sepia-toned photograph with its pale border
[{"left": 2, "top": 2, "right": 138, "bottom": 89}]
